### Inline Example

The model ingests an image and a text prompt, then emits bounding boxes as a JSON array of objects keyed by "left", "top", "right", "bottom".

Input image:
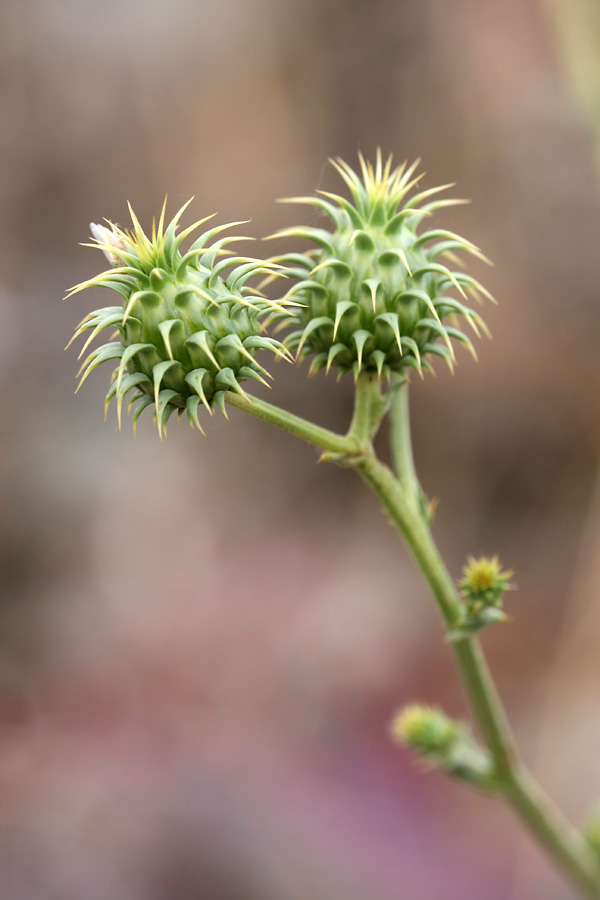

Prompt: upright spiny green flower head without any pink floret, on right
[{"left": 273, "top": 153, "right": 492, "bottom": 378}]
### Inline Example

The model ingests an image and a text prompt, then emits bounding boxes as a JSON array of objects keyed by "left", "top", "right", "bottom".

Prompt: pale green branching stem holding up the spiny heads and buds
[{"left": 227, "top": 373, "right": 600, "bottom": 900}]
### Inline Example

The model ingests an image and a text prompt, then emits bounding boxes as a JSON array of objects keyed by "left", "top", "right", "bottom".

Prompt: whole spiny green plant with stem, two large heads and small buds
[{"left": 71, "top": 153, "right": 600, "bottom": 898}]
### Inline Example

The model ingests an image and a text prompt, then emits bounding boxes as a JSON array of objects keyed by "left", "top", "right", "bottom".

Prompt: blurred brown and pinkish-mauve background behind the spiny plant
[{"left": 0, "top": 0, "right": 600, "bottom": 900}]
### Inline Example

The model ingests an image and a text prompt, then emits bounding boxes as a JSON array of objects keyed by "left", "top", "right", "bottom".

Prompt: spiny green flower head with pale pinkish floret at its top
[{"left": 69, "top": 201, "right": 289, "bottom": 434}]
